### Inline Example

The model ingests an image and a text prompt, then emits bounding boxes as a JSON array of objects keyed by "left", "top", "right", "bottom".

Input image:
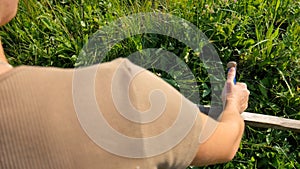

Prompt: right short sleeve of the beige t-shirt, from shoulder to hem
[{"left": 112, "top": 59, "right": 202, "bottom": 168}]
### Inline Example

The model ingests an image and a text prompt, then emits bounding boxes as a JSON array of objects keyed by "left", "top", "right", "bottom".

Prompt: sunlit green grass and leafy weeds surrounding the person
[{"left": 0, "top": 0, "right": 300, "bottom": 169}]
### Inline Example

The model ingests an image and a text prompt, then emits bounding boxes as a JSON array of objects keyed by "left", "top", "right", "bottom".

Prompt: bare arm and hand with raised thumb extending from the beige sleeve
[{"left": 192, "top": 66, "right": 250, "bottom": 166}]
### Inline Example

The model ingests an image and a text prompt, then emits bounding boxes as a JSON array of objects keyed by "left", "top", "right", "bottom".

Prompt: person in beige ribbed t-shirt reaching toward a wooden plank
[{"left": 0, "top": 0, "right": 249, "bottom": 169}]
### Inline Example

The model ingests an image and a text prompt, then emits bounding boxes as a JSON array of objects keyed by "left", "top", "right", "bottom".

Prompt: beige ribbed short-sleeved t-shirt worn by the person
[{"left": 0, "top": 59, "right": 202, "bottom": 169}]
